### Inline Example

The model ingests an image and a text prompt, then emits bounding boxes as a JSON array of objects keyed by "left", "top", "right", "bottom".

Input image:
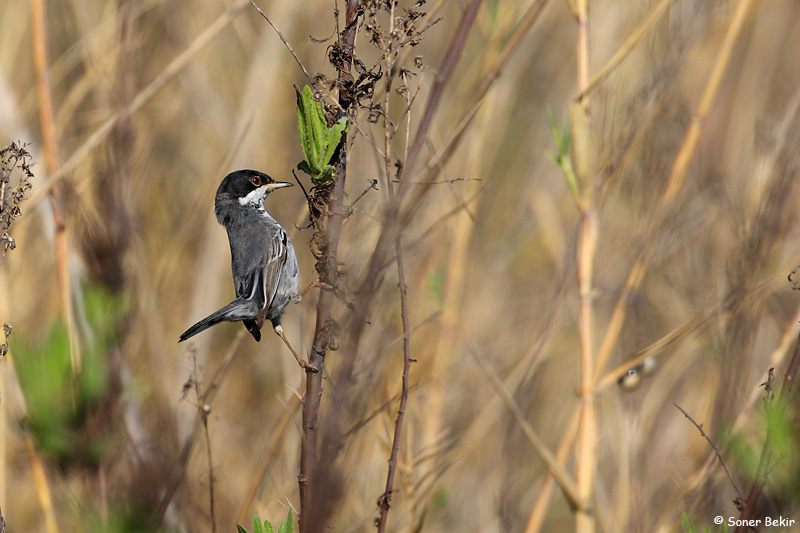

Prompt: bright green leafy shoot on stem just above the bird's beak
[{"left": 295, "top": 85, "right": 350, "bottom": 185}]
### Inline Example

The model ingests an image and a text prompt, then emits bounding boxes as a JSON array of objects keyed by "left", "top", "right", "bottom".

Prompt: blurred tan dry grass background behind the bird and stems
[{"left": 0, "top": 0, "right": 800, "bottom": 532}]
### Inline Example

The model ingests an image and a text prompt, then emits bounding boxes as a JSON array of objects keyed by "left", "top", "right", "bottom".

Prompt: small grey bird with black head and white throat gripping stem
[{"left": 178, "top": 170, "right": 316, "bottom": 372}]
